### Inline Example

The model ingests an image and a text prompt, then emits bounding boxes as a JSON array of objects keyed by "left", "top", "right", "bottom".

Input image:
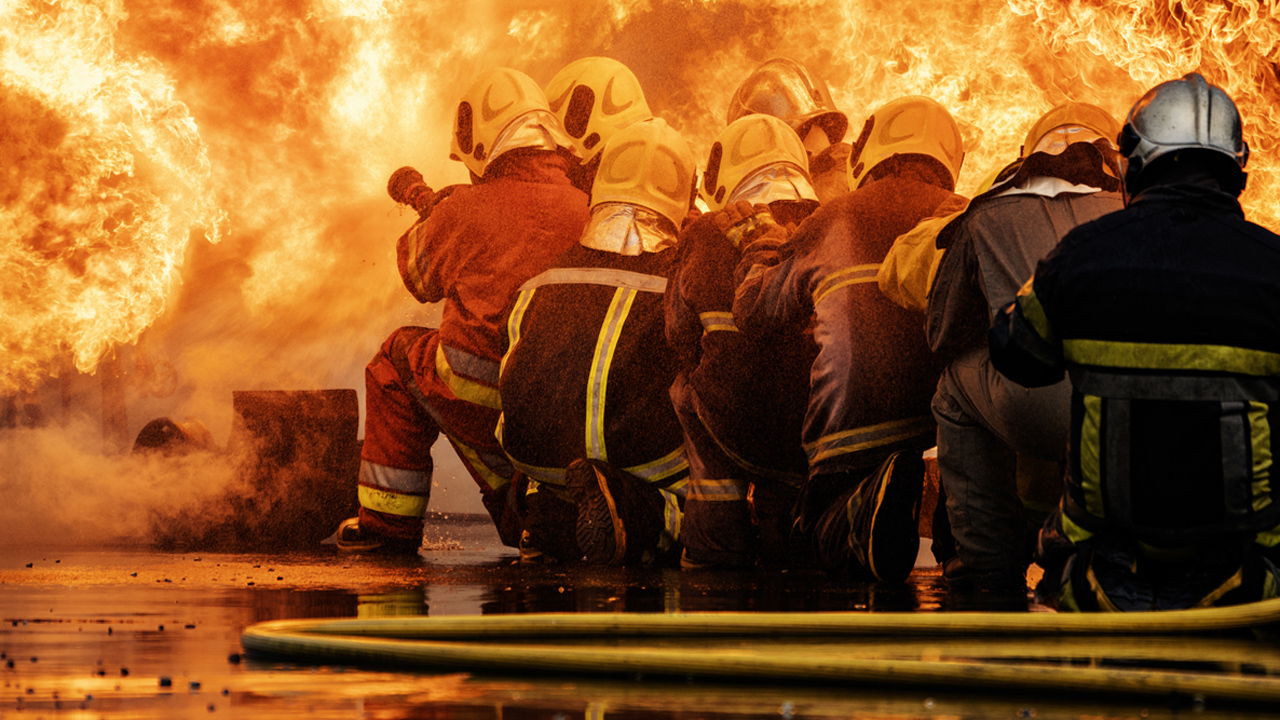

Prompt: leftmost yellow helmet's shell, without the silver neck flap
[{"left": 449, "top": 68, "right": 559, "bottom": 177}]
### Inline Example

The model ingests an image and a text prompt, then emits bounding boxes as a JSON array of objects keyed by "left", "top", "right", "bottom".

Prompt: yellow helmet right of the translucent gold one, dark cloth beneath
[{"left": 849, "top": 95, "right": 964, "bottom": 190}]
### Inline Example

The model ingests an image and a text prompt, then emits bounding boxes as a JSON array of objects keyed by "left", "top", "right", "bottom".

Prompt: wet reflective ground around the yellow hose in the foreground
[{"left": 0, "top": 516, "right": 1280, "bottom": 720}]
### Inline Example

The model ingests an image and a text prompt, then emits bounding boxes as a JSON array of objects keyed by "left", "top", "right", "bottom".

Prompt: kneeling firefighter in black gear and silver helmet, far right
[{"left": 989, "top": 73, "right": 1280, "bottom": 611}]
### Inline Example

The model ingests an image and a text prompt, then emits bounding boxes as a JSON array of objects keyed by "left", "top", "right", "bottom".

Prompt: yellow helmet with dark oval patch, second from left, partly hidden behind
[{"left": 547, "top": 58, "right": 653, "bottom": 164}]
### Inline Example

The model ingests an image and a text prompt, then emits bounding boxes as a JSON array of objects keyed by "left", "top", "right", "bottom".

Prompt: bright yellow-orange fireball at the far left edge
[{"left": 0, "top": 3, "right": 219, "bottom": 391}]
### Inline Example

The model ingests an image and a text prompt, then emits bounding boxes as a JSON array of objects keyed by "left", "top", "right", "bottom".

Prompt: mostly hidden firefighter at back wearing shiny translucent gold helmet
[{"left": 724, "top": 58, "right": 851, "bottom": 202}]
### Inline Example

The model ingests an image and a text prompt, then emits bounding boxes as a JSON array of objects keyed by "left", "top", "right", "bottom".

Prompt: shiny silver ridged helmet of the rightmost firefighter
[{"left": 1119, "top": 73, "right": 1249, "bottom": 193}]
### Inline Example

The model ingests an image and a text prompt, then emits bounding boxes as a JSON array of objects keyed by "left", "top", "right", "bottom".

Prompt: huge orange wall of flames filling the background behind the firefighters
[{"left": 0, "top": 0, "right": 1280, "bottom": 420}]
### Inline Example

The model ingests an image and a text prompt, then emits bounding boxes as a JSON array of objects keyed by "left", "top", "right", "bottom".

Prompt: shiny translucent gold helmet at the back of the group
[{"left": 724, "top": 58, "right": 849, "bottom": 145}]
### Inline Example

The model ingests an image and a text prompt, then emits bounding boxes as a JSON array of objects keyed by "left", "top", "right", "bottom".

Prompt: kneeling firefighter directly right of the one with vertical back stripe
[{"left": 666, "top": 114, "right": 818, "bottom": 568}]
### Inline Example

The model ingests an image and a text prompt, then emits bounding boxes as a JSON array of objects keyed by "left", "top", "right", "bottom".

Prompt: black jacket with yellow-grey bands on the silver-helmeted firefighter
[{"left": 992, "top": 186, "right": 1280, "bottom": 547}]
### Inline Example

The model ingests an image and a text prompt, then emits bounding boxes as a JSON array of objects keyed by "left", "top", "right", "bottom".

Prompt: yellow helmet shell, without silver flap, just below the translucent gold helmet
[{"left": 699, "top": 115, "right": 817, "bottom": 210}]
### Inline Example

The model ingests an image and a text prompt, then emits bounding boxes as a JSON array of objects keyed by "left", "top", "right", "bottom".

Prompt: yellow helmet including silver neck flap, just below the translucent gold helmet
[{"left": 699, "top": 114, "right": 818, "bottom": 210}]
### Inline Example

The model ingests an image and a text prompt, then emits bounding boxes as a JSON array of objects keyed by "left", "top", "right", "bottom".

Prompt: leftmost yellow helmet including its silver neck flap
[{"left": 449, "top": 68, "right": 570, "bottom": 177}]
